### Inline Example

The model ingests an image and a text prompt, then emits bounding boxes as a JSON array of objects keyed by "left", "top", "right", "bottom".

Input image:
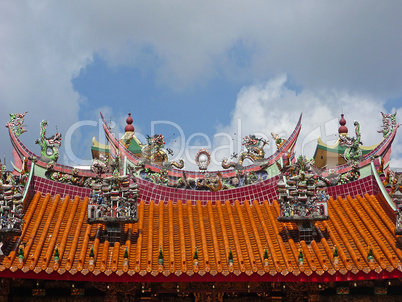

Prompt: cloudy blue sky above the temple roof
[{"left": 0, "top": 0, "right": 402, "bottom": 169}]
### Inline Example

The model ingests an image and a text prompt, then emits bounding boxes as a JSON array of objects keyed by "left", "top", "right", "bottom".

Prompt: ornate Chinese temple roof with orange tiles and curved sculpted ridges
[{"left": 0, "top": 110, "right": 402, "bottom": 288}]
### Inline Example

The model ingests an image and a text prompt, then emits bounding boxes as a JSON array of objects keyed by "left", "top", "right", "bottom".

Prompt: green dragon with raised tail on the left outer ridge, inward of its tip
[{"left": 35, "top": 121, "right": 61, "bottom": 163}]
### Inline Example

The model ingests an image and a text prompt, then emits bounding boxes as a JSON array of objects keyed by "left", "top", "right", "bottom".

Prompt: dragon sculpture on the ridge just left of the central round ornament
[{"left": 141, "top": 134, "right": 184, "bottom": 169}]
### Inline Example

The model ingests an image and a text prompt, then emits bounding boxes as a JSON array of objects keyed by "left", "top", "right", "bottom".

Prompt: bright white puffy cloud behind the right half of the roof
[{"left": 214, "top": 76, "right": 402, "bottom": 170}]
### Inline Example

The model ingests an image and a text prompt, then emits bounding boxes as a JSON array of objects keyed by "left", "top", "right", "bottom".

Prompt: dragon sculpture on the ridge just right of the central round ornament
[{"left": 222, "top": 134, "right": 269, "bottom": 169}]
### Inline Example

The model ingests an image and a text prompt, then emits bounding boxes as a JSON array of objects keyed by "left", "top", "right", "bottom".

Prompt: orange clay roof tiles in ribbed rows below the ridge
[{"left": 0, "top": 192, "right": 402, "bottom": 280}]
